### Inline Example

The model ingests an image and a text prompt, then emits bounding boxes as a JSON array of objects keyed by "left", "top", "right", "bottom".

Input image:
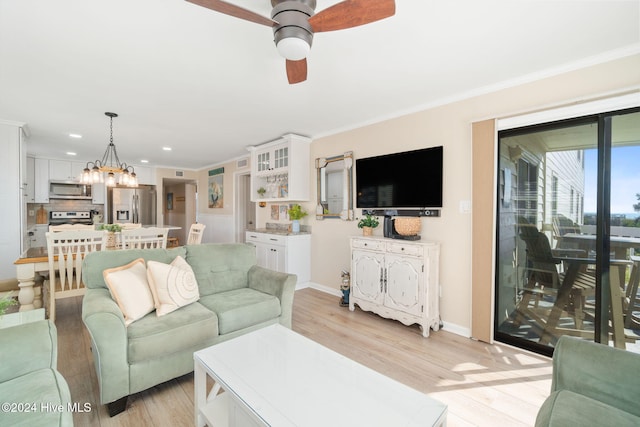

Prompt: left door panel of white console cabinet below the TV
[{"left": 351, "top": 250, "right": 384, "bottom": 304}]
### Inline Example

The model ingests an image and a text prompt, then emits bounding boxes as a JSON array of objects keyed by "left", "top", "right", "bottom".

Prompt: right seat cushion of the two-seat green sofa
[{"left": 200, "top": 288, "right": 281, "bottom": 335}]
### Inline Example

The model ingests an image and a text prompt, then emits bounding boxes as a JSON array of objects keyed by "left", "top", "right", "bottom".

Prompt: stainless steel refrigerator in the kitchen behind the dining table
[{"left": 107, "top": 185, "right": 157, "bottom": 225}]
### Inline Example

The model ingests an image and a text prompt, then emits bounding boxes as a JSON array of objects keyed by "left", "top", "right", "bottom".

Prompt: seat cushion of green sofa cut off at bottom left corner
[{"left": 0, "top": 368, "right": 73, "bottom": 427}]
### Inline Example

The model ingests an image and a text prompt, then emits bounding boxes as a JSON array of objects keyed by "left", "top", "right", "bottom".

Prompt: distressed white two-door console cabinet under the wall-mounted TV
[{"left": 349, "top": 237, "right": 440, "bottom": 337}]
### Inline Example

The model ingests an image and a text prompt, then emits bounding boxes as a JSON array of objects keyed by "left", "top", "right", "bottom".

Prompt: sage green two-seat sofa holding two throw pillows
[{"left": 82, "top": 243, "right": 296, "bottom": 416}]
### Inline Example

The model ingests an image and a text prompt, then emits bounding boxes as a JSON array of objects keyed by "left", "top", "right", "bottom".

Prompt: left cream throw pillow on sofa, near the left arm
[{"left": 102, "top": 258, "right": 155, "bottom": 326}]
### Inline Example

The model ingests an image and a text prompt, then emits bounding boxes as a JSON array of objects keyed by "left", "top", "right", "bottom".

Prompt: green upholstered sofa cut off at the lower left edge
[{"left": 0, "top": 320, "right": 73, "bottom": 427}]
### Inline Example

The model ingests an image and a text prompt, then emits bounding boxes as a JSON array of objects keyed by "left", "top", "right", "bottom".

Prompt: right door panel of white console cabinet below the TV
[{"left": 384, "top": 254, "right": 424, "bottom": 315}]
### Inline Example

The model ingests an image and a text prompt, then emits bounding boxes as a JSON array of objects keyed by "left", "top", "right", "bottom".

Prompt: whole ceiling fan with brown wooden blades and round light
[{"left": 187, "top": 0, "right": 396, "bottom": 84}]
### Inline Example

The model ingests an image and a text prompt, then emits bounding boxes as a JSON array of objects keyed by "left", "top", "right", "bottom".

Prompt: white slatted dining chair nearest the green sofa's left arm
[{"left": 44, "top": 230, "right": 107, "bottom": 322}]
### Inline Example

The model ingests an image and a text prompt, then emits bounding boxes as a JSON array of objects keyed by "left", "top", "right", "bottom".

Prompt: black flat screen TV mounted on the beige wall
[{"left": 356, "top": 147, "right": 443, "bottom": 209}]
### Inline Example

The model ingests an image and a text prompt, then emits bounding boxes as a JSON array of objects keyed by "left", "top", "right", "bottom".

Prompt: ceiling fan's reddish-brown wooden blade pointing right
[{"left": 309, "top": 0, "right": 396, "bottom": 33}]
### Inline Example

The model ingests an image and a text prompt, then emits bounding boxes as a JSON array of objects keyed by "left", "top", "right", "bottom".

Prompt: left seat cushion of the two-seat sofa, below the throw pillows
[{"left": 127, "top": 302, "right": 218, "bottom": 364}]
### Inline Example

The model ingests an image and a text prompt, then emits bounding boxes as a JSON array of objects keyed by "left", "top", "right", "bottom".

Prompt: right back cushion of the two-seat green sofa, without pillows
[{"left": 185, "top": 243, "right": 256, "bottom": 297}]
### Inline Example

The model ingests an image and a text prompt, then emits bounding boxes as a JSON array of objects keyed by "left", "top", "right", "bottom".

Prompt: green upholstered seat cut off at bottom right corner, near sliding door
[{"left": 536, "top": 336, "right": 640, "bottom": 427}]
